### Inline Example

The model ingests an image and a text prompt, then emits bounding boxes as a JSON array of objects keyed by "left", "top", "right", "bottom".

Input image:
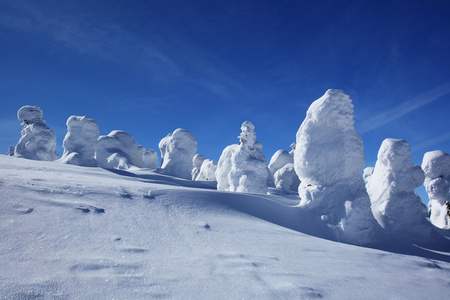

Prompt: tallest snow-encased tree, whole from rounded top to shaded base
[{"left": 294, "top": 90, "right": 381, "bottom": 246}]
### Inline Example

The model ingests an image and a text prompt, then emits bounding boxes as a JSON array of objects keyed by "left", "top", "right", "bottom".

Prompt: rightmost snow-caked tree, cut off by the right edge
[{"left": 422, "top": 150, "right": 450, "bottom": 229}]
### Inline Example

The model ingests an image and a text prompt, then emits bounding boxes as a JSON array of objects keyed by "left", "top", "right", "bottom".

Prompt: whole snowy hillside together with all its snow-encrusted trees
[{"left": 0, "top": 90, "right": 450, "bottom": 299}]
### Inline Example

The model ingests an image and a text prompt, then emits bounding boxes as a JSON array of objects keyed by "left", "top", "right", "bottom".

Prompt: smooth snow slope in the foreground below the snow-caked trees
[{"left": 0, "top": 155, "right": 450, "bottom": 299}]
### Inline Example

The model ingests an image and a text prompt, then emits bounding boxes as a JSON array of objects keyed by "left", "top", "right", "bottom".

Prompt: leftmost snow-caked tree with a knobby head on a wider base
[{"left": 14, "top": 105, "right": 59, "bottom": 161}]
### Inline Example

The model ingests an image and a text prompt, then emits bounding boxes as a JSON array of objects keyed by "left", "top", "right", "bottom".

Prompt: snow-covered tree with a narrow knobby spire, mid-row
[{"left": 216, "top": 121, "right": 270, "bottom": 194}]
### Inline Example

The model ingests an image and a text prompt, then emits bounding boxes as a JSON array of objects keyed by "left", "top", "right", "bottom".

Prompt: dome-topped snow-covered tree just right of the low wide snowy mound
[{"left": 159, "top": 128, "right": 197, "bottom": 179}]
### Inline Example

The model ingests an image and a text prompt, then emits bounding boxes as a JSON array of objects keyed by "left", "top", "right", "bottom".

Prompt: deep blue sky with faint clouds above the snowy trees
[{"left": 0, "top": 0, "right": 450, "bottom": 199}]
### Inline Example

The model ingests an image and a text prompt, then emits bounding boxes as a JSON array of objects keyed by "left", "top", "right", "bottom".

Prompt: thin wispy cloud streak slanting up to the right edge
[{"left": 359, "top": 82, "right": 450, "bottom": 134}]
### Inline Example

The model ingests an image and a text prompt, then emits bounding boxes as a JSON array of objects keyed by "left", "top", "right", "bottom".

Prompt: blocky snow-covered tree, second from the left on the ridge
[{"left": 59, "top": 116, "right": 99, "bottom": 167}]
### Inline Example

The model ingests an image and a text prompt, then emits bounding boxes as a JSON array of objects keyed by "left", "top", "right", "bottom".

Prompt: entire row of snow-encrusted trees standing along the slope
[{"left": 9, "top": 90, "right": 450, "bottom": 247}]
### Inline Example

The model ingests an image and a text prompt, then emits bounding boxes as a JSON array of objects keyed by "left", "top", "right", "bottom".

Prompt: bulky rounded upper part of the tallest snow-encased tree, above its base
[{"left": 294, "top": 90, "right": 365, "bottom": 185}]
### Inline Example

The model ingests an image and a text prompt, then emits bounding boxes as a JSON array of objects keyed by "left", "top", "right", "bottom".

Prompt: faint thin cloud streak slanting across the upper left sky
[{"left": 0, "top": 1, "right": 248, "bottom": 98}]
